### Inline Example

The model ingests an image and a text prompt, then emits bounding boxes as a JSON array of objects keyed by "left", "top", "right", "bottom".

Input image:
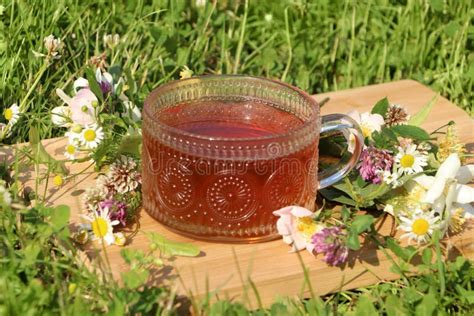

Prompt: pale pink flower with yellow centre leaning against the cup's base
[{"left": 273, "top": 205, "right": 319, "bottom": 253}]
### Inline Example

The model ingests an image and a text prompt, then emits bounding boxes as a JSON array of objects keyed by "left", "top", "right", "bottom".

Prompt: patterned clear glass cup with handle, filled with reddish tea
[{"left": 142, "top": 75, "right": 363, "bottom": 243}]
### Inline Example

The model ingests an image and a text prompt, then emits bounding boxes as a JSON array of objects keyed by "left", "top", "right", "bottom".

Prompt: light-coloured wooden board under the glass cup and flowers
[{"left": 0, "top": 80, "right": 474, "bottom": 308}]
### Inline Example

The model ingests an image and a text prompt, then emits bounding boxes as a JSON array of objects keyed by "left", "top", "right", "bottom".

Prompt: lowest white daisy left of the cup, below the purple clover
[{"left": 82, "top": 207, "right": 120, "bottom": 245}]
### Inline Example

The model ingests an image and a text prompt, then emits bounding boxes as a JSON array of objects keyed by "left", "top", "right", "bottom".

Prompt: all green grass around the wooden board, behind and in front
[{"left": 0, "top": 0, "right": 474, "bottom": 315}]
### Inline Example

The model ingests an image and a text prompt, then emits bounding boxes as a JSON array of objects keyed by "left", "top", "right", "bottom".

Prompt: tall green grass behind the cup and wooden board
[{"left": 0, "top": 0, "right": 474, "bottom": 142}]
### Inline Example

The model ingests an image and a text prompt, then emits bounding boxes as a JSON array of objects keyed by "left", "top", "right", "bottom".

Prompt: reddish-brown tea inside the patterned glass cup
[{"left": 142, "top": 101, "right": 318, "bottom": 242}]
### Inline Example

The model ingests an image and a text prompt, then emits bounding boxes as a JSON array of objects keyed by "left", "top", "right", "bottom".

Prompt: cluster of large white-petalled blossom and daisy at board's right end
[{"left": 384, "top": 154, "right": 474, "bottom": 243}]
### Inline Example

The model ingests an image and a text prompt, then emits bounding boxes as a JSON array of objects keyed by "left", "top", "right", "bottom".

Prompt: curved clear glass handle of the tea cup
[{"left": 318, "top": 114, "right": 364, "bottom": 189}]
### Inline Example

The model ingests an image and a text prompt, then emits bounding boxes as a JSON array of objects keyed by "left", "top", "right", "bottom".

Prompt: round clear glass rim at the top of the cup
[{"left": 143, "top": 74, "right": 320, "bottom": 142}]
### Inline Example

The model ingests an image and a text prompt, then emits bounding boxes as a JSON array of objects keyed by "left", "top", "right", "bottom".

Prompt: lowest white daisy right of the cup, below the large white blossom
[{"left": 398, "top": 209, "right": 440, "bottom": 244}]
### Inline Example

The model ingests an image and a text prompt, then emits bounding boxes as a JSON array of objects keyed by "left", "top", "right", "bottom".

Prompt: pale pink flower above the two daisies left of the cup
[{"left": 56, "top": 88, "right": 98, "bottom": 126}]
